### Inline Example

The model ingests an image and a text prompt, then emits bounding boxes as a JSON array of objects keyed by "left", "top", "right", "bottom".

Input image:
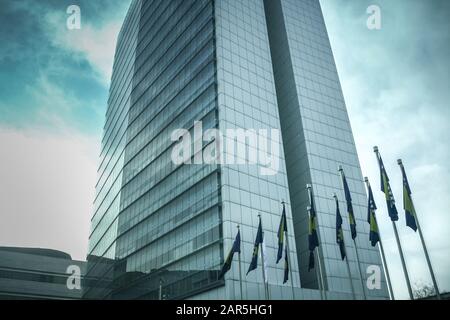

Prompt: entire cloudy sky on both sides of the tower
[{"left": 0, "top": 0, "right": 450, "bottom": 298}]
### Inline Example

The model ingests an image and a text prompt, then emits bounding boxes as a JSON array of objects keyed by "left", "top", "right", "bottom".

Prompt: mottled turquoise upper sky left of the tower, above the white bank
[{"left": 0, "top": 0, "right": 129, "bottom": 135}]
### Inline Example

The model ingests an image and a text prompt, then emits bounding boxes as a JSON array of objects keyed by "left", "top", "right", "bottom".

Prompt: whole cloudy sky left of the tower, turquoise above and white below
[{"left": 0, "top": 0, "right": 129, "bottom": 259}]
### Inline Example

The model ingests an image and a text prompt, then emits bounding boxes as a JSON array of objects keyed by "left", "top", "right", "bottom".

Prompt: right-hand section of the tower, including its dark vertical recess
[{"left": 266, "top": 0, "right": 388, "bottom": 298}]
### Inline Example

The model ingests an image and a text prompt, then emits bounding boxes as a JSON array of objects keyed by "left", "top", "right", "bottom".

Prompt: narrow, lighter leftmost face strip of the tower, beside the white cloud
[{"left": 84, "top": 1, "right": 141, "bottom": 298}]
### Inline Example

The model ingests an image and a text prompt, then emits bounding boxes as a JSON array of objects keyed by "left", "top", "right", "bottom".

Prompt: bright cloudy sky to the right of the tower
[{"left": 321, "top": 0, "right": 450, "bottom": 298}]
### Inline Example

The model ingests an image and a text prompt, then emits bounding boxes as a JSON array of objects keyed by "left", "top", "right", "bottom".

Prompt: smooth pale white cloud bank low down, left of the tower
[{"left": 0, "top": 129, "right": 99, "bottom": 260}]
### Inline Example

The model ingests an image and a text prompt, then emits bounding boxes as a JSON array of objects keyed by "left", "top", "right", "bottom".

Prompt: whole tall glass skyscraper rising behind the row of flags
[{"left": 84, "top": 0, "right": 388, "bottom": 299}]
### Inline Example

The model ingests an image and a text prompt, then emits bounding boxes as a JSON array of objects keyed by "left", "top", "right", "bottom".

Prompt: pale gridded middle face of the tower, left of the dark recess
[{"left": 211, "top": 0, "right": 301, "bottom": 299}]
